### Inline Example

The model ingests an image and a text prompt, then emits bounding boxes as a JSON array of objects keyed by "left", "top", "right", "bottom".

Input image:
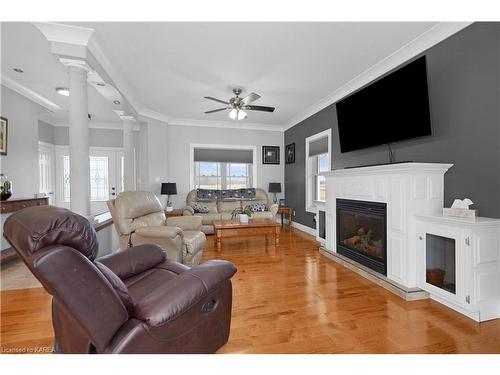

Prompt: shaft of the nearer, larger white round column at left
[{"left": 68, "top": 65, "right": 90, "bottom": 217}]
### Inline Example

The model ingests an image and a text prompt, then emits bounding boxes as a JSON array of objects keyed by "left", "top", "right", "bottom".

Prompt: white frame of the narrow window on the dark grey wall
[{"left": 305, "top": 128, "right": 332, "bottom": 214}]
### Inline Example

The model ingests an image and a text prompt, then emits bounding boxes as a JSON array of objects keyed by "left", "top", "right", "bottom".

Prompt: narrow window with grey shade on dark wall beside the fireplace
[{"left": 306, "top": 129, "right": 331, "bottom": 213}]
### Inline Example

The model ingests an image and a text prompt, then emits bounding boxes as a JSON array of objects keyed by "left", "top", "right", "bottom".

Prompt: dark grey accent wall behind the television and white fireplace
[{"left": 285, "top": 23, "right": 500, "bottom": 227}]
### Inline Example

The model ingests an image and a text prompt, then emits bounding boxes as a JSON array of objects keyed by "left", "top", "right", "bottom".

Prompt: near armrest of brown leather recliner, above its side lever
[{"left": 135, "top": 260, "right": 236, "bottom": 326}]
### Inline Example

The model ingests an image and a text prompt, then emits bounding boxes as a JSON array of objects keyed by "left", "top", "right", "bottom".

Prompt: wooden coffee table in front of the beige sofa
[{"left": 214, "top": 219, "right": 281, "bottom": 251}]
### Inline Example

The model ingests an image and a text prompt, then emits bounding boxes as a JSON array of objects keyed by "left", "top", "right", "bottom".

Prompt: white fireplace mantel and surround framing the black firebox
[{"left": 322, "top": 163, "right": 453, "bottom": 288}]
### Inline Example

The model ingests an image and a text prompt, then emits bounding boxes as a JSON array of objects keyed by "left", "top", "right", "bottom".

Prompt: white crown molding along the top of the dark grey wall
[{"left": 283, "top": 22, "right": 472, "bottom": 130}]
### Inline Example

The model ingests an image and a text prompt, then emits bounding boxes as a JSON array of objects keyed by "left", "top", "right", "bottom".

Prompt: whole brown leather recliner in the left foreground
[{"left": 4, "top": 206, "right": 236, "bottom": 353}]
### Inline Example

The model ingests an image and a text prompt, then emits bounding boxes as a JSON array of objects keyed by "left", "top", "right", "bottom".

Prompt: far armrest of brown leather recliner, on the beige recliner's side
[{"left": 96, "top": 244, "right": 166, "bottom": 280}]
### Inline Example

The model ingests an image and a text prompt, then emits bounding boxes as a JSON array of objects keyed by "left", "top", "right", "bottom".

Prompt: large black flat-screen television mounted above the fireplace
[{"left": 337, "top": 56, "right": 431, "bottom": 152}]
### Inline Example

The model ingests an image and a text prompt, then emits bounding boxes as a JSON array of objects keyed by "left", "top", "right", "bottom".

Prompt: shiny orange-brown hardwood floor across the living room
[{"left": 1, "top": 230, "right": 500, "bottom": 353}]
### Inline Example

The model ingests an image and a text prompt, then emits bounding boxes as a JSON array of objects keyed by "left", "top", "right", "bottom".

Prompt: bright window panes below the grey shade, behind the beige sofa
[{"left": 194, "top": 161, "right": 252, "bottom": 190}]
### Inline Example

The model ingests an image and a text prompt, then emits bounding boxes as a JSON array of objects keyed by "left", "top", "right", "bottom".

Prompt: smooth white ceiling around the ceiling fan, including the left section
[{"left": 2, "top": 22, "right": 464, "bottom": 130}]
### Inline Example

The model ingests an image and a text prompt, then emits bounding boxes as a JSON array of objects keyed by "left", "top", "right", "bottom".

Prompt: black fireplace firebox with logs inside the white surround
[{"left": 337, "top": 199, "right": 387, "bottom": 275}]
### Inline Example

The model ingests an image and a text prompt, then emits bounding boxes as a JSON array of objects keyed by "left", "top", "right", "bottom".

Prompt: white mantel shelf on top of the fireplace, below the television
[{"left": 320, "top": 163, "right": 453, "bottom": 176}]
